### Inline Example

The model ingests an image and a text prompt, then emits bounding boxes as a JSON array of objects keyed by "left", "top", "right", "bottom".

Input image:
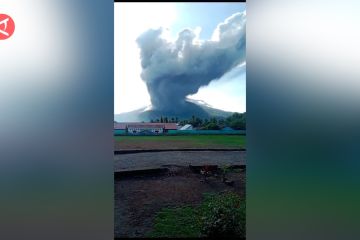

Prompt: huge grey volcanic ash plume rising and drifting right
[{"left": 137, "top": 12, "right": 246, "bottom": 111}]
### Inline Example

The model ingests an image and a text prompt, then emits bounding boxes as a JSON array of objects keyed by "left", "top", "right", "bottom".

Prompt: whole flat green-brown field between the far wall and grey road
[{"left": 114, "top": 135, "right": 246, "bottom": 150}]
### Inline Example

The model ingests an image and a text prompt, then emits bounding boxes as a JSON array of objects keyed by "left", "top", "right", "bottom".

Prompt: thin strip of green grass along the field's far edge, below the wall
[{"left": 115, "top": 135, "right": 246, "bottom": 148}]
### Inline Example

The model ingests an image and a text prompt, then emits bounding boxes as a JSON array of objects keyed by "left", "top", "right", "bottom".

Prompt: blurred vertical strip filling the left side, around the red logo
[{"left": 0, "top": 0, "right": 114, "bottom": 239}]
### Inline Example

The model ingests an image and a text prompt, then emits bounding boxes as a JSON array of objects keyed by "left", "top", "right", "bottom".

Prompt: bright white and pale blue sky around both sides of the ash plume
[{"left": 114, "top": 2, "right": 246, "bottom": 114}]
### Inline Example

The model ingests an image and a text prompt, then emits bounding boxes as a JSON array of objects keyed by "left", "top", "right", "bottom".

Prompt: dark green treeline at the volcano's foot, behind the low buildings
[{"left": 151, "top": 113, "right": 246, "bottom": 130}]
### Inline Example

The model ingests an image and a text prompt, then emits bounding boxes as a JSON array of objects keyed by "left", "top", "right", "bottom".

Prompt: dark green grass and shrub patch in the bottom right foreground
[{"left": 147, "top": 192, "right": 246, "bottom": 239}]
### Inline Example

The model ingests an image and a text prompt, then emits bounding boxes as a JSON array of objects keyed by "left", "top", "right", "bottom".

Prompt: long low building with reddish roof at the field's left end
[{"left": 114, "top": 122, "right": 177, "bottom": 135}]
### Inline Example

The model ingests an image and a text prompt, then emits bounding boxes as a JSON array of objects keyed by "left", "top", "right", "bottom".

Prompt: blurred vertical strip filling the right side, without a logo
[{"left": 246, "top": 0, "right": 360, "bottom": 240}]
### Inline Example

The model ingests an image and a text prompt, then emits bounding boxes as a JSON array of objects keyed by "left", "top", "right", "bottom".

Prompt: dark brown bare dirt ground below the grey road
[{"left": 114, "top": 166, "right": 246, "bottom": 238}]
